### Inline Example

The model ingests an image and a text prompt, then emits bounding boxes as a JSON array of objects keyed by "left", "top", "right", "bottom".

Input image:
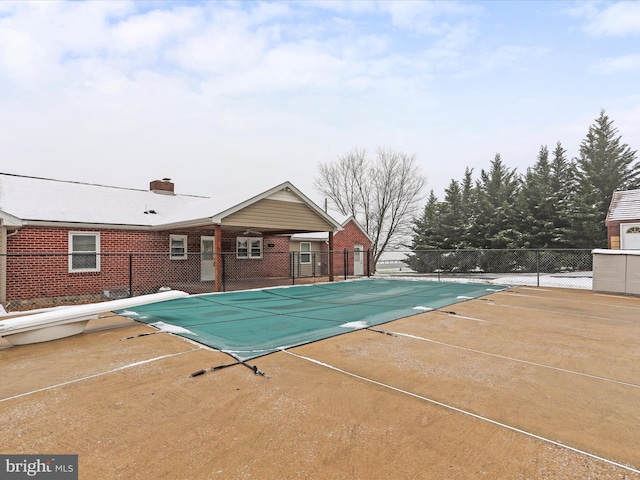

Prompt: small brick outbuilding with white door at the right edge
[{"left": 605, "top": 189, "right": 640, "bottom": 250}]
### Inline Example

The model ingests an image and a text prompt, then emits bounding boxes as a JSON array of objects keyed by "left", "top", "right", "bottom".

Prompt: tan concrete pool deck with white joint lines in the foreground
[{"left": 0, "top": 287, "right": 640, "bottom": 480}]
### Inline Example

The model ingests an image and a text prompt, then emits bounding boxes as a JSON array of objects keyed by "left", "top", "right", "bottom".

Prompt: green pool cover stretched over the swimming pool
[{"left": 117, "top": 279, "right": 508, "bottom": 361}]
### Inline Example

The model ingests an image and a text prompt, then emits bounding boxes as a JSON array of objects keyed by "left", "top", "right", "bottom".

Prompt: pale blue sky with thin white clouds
[{"left": 0, "top": 0, "right": 640, "bottom": 205}]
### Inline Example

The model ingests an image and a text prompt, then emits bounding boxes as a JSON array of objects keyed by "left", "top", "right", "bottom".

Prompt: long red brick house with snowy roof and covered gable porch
[{"left": 0, "top": 173, "right": 370, "bottom": 306}]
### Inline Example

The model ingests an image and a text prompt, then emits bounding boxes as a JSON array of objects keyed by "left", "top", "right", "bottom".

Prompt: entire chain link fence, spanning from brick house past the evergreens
[{"left": 0, "top": 249, "right": 592, "bottom": 311}]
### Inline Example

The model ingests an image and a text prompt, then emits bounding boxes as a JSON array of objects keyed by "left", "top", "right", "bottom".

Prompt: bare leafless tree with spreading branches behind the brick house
[{"left": 315, "top": 148, "right": 427, "bottom": 265}]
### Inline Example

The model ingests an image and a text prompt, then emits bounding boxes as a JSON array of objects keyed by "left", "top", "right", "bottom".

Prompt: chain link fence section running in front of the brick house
[{"left": 0, "top": 250, "right": 371, "bottom": 311}]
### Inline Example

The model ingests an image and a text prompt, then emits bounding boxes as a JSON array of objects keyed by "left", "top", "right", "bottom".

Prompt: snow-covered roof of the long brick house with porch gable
[{"left": 0, "top": 173, "right": 340, "bottom": 230}]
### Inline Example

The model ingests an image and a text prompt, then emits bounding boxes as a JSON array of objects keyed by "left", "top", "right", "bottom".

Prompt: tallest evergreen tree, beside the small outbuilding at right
[{"left": 569, "top": 110, "right": 640, "bottom": 248}]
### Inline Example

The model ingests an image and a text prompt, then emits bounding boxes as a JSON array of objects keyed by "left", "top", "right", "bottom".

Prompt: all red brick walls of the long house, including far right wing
[{"left": 6, "top": 223, "right": 371, "bottom": 308}]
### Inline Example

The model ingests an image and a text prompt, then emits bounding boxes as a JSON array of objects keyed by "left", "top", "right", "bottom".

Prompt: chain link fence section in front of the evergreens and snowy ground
[{"left": 376, "top": 249, "right": 593, "bottom": 289}]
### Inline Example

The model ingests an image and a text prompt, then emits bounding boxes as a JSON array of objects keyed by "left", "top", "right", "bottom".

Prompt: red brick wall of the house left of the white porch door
[{"left": 6, "top": 227, "right": 218, "bottom": 301}]
